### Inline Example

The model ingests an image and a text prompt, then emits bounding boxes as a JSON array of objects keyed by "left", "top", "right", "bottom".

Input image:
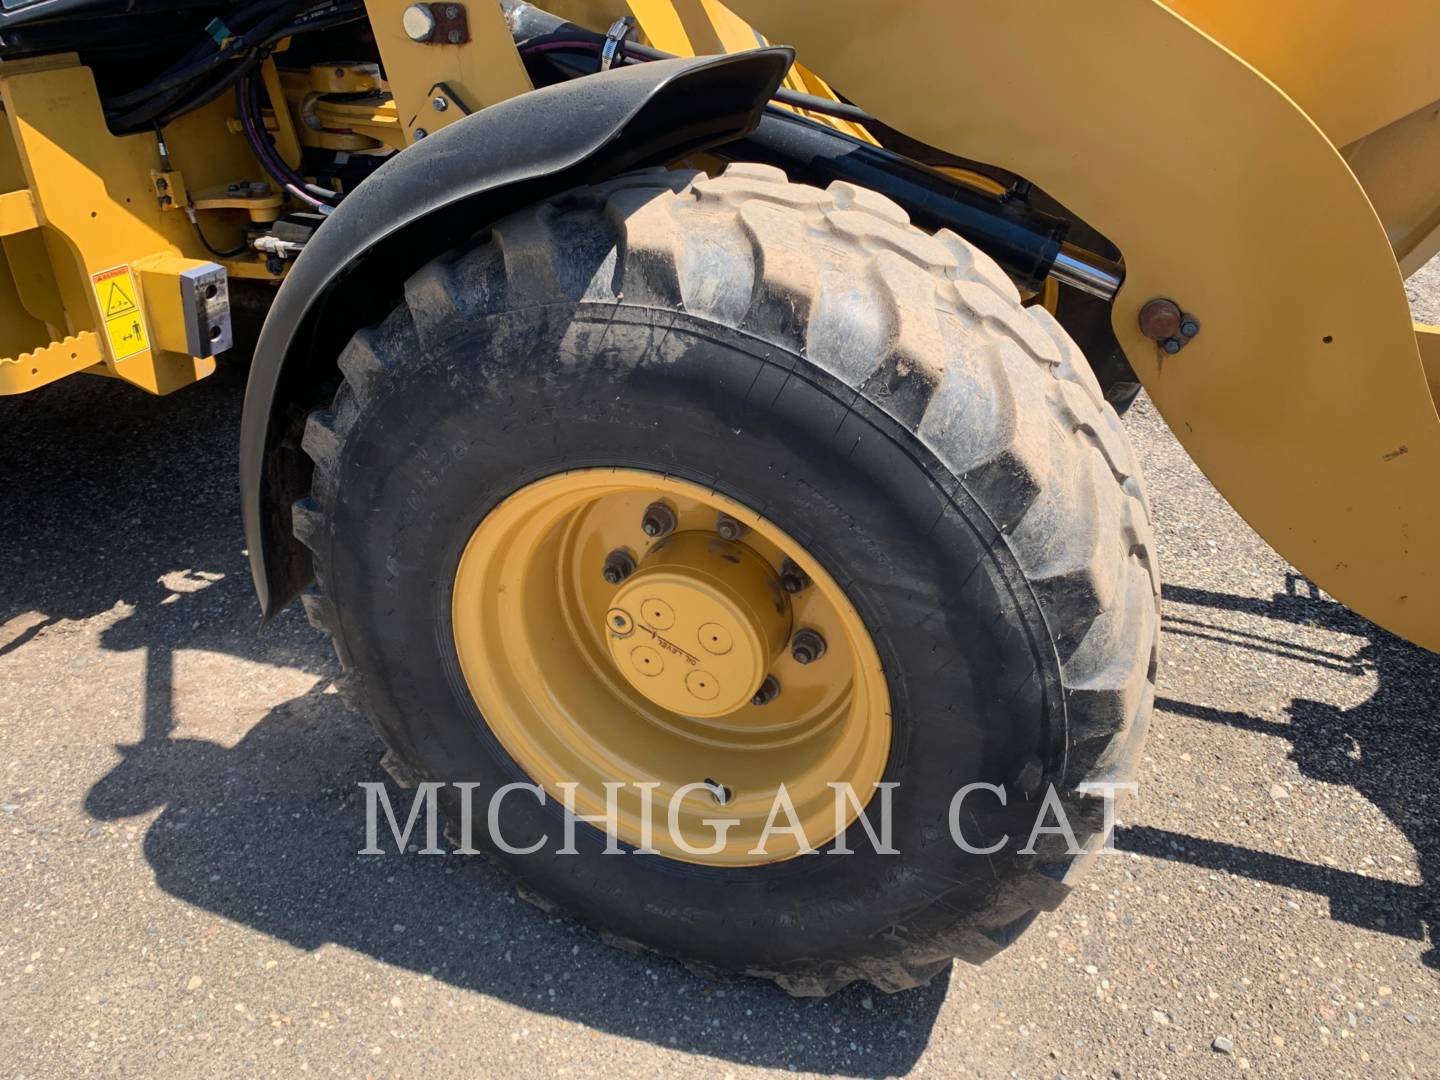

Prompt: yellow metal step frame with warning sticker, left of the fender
[{"left": 0, "top": 55, "right": 256, "bottom": 393}]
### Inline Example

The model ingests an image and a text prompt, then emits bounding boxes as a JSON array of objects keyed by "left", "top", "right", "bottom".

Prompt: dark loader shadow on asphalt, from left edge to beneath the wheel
[{"left": 0, "top": 355, "right": 949, "bottom": 1076}]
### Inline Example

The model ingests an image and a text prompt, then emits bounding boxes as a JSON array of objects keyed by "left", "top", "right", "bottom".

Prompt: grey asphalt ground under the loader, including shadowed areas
[{"left": 0, "top": 268, "right": 1440, "bottom": 1077}]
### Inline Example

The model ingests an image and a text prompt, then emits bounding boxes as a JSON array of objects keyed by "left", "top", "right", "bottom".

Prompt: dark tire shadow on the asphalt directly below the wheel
[{"left": 85, "top": 668, "right": 949, "bottom": 1076}]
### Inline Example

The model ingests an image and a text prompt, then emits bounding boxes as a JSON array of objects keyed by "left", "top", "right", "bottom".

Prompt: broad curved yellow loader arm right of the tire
[{"left": 730, "top": 0, "right": 1440, "bottom": 649}]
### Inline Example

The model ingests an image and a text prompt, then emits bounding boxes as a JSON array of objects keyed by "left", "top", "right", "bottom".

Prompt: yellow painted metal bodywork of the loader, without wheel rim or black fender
[{"left": 0, "top": 0, "right": 1440, "bottom": 649}]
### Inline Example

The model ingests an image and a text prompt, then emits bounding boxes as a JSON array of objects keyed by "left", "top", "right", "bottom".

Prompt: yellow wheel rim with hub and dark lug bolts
[{"left": 451, "top": 469, "right": 890, "bottom": 867}]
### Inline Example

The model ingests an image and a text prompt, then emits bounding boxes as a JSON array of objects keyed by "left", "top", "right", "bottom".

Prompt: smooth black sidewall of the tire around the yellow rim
[{"left": 323, "top": 304, "right": 1066, "bottom": 971}]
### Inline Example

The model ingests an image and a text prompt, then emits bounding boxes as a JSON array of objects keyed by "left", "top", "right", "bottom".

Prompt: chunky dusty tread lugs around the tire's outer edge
[{"left": 295, "top": 164, "right": 1159, "bottom": 996}]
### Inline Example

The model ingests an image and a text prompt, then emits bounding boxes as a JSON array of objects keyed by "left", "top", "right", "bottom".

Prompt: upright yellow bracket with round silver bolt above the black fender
[{"left": 366, "top": 0, "right": 533, "bottom": 140}]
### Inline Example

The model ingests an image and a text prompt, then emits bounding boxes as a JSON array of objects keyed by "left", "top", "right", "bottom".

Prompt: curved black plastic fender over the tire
[{"left": 240, "top": 48, "right": 795, "bottom": 619}]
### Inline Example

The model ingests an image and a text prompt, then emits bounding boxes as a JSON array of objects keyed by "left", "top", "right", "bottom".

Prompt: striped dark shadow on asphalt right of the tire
[{"left": 1116, "top": 575, "right": 1440, "bottom": 969}]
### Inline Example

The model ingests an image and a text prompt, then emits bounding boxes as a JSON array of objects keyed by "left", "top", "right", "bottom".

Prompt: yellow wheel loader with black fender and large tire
[{"left": 0, "top": 0, "right": 1440, "bottom": 995}]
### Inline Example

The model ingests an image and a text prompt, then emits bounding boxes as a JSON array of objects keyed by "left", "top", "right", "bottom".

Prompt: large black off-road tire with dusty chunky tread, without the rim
[{"left": 294, "top": 164, "right": 1159, "bottom": 995}]
